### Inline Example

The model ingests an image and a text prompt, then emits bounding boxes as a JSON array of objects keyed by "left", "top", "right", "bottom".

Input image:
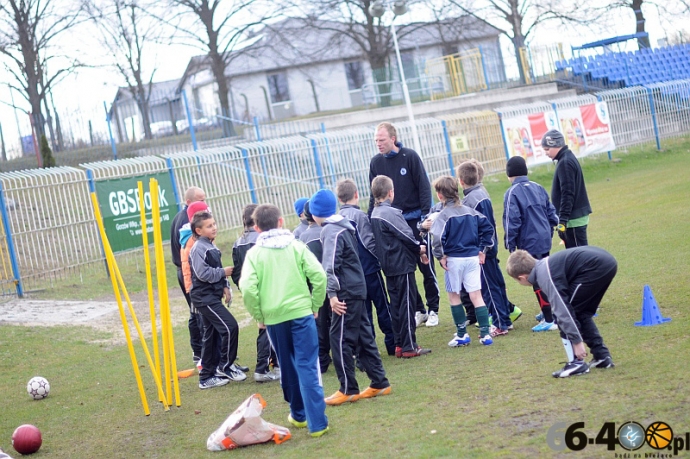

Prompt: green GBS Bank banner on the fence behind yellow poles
[{"left": 96, "top": 172, "right": 177, "bottom": 253}]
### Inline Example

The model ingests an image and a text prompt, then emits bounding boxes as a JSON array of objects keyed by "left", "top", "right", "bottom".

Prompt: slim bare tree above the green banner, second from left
[{"left": 84, "top": 0, "right": 160, "bottom": 139}]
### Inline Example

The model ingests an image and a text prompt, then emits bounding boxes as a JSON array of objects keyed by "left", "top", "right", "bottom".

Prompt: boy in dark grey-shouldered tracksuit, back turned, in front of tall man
[{"left": 371, "top": 175, "right": 431, "bottom": 359}]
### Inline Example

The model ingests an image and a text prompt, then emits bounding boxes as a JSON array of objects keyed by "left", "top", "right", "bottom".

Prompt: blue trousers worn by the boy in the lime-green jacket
[{"left": 266, "top": 315, "right": 328, "bottom": 432}]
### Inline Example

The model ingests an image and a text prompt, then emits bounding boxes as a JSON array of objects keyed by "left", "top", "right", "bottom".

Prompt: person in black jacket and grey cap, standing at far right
[{"left": 541, "top": 129, "right": 592, "bottom": 249}]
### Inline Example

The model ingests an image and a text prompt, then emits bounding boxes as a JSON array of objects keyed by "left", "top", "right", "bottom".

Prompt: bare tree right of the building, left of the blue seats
[{"left": 449, "top": 0, "right": 584, "bottom": 83}]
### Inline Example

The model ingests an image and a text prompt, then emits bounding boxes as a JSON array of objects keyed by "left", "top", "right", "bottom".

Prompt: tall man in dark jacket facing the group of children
[{"left": 368, "top": 122, "right": 441, "bottom": 326}]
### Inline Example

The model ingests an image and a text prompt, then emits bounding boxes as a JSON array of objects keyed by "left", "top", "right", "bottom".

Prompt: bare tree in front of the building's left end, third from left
[{"left": 165, "top": 0, "right": 276, "bottom": 137}]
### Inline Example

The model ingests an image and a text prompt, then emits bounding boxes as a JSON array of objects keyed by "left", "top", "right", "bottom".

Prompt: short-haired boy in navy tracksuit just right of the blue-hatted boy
[{"left": 336, "top": 179, "right": 395, "bottom": 355}]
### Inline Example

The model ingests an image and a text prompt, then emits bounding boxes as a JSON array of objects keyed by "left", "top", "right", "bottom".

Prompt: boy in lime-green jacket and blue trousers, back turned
[{"left": 239, "top": 204, "right": 328, "bottom": 437}]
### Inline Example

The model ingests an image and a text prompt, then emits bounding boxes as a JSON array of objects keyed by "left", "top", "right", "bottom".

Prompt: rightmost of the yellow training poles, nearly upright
[{"left": 149, "top": 178, "right": 181, "bottom": 406}]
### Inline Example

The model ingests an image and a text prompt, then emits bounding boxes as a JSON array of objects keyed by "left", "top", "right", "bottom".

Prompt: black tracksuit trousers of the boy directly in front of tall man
[{"left": 386, "top": 272, "right": 419, "bottom": 352}]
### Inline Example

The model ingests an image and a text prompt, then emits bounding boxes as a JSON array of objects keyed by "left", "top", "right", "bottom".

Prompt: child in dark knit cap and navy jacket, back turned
[{"left": 503, "top": 156, "right": 558, "bottom": 332}]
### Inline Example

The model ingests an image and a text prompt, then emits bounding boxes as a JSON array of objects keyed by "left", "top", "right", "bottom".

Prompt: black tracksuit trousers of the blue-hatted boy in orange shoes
[{"left": 331, "top": 299, "right": 390, "bottom": 395}]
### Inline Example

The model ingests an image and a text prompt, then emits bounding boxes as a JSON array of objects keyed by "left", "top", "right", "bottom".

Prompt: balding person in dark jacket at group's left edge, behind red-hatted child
[{"left": 170, "top": 186, "right": 206, "bottom": 365}]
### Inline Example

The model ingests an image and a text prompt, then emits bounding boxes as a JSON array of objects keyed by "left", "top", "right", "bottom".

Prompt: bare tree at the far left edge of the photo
[{"left": 0, "top": 0, "right": 83, "bottom": 138}]
